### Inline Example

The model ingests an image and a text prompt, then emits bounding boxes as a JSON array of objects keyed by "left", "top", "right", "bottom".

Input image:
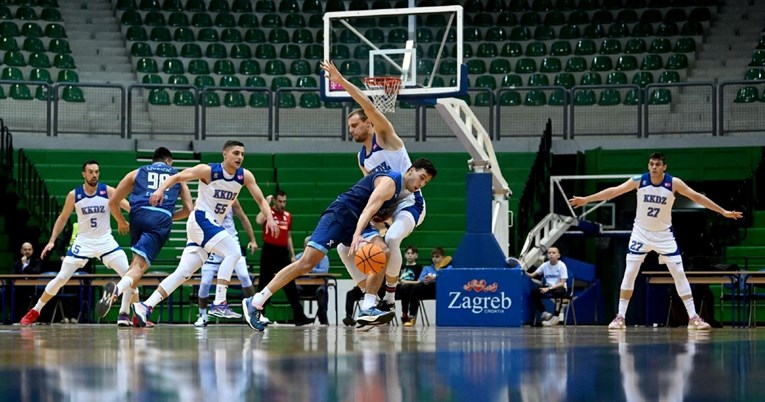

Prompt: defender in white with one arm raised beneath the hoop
[{"left": 321, "top": 61, "right": 425, "bottom": 318}]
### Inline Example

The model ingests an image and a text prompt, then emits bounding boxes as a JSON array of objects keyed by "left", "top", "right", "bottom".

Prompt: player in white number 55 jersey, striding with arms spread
[{"left": 133, "top": 141, "right": 279, "bottom": 327}]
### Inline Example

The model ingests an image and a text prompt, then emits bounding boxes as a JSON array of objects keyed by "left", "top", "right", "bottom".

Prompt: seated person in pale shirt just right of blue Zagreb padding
[{"left": 526, "top": 246, "right": 568, "bottom": 327}]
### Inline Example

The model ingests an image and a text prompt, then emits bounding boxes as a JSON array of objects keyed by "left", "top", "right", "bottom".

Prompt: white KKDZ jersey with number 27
[{"left": 632, "top": 173, "right": 675, "bottom": 232}]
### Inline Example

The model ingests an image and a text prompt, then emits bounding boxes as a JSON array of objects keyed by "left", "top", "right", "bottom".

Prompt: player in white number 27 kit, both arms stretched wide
[{"left": 568, "top": 152, "right": 743, "bottom": 330}]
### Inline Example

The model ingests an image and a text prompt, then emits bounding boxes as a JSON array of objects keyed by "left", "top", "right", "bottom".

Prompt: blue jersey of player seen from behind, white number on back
[{"left": 130, "top": 162, "right": 181, "bottom": 215}]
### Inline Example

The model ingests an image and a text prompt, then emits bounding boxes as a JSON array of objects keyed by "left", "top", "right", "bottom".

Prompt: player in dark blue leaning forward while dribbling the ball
[{"left": 242, "top": 158, "right": 436, "bottom": 331}]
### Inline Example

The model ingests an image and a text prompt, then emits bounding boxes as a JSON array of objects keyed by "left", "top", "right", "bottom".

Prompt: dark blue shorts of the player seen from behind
[{"left": 130, "top": 208, "right": 173, "bottom": 265}]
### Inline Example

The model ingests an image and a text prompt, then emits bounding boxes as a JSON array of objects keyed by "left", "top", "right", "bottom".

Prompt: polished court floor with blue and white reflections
[{"left": 0, "top": 324, "right": 765, "bottom": 402}]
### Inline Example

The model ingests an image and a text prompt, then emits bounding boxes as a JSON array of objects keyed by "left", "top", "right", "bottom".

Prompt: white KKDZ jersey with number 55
[{"left": 194, "top": 163, "right": 244, "bottom": 225}]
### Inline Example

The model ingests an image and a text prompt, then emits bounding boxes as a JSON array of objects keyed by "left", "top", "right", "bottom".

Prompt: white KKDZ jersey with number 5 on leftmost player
[{"left": 74, "top": 183, "right": 112, "bottom": 239}]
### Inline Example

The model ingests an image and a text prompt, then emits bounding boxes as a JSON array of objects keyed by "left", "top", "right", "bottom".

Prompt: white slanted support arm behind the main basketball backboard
[{"left": 436, "top": 98, "right": 512, "bottom": 257}]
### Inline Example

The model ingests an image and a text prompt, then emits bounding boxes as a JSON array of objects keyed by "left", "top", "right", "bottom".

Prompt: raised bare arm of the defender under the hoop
[{"left": 321, "top": 60, "right": 404, "bottom": 150}]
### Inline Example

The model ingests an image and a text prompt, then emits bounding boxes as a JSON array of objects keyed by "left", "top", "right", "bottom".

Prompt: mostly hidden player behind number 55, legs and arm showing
[{"left": 194, "top": 200, "right": 258, "bottom": 327}]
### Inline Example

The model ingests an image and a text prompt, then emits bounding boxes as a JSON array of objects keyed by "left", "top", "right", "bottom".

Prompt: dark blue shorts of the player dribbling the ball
[{"left": 308, "top": 201, "right": 359, "bottom": 254}]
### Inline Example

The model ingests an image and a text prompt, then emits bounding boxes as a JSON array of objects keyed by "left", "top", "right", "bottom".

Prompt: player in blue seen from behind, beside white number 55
[{"left": 96, "top": 147, "right": 192, "bottom": 327}]
